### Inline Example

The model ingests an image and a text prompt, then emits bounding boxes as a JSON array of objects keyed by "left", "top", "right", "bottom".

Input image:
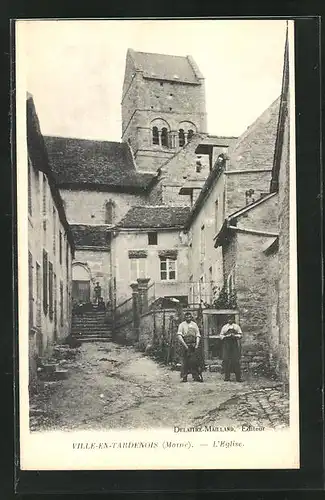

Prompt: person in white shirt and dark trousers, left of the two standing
[{"left": 177, "top": 312, "right": 203, "bottom": 382}]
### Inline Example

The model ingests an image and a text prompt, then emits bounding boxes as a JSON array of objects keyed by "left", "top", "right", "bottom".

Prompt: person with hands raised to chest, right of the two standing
[{"left": 220, "top": 318, "right": 242, "bottom": 382}]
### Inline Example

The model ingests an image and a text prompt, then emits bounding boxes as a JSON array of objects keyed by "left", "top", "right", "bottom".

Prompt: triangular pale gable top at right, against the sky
[{"left": 227, "top": 97, "right": 280, "bottom": 170}]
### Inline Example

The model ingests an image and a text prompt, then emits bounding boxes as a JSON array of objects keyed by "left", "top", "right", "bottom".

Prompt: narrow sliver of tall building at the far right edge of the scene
[{"left": 265, "top": 31, "right": 295, "bottom": 383}]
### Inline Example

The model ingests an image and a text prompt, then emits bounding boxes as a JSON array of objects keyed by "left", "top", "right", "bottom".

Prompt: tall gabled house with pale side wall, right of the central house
[{"left": 180, "top": 94, "right": 279, "bottom": 305}]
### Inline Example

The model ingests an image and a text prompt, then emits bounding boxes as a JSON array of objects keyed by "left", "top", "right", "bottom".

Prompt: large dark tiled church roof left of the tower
[{"left": 44, "top": 136, "right": 154, "bottom": 190}]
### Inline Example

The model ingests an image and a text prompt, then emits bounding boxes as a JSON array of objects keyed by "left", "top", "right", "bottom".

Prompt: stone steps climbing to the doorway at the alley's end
[{"left": 71, "top": 309, "right": 112, "bottom": 342}]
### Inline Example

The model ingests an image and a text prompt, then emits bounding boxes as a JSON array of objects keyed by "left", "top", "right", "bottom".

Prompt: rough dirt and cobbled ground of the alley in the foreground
[{"left": 30, "top": 342, "right": 289, "bottom": 431}]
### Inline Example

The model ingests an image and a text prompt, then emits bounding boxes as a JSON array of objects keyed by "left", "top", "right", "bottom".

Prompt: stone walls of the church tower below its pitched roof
[{"left": 122, "top": 52, "right": 206, "bottom": 172}]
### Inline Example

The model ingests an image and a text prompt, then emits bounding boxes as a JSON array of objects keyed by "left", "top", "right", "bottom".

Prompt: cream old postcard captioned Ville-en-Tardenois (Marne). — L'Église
[{"left": 15, "top": 18, "right": 299, "bottom": 470}]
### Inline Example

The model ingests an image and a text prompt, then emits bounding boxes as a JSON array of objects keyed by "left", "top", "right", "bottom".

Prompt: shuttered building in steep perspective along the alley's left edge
[{"left": 27, "top": 94, "right": 74, "bottom": 381}]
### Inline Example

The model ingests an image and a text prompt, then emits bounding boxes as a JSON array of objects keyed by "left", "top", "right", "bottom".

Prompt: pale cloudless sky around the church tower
[{"left": 17, "top": 20, "right": 286, "bottom": 141}]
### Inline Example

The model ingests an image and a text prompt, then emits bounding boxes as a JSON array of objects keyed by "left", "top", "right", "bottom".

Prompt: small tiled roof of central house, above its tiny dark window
[{"left": 117, "top": 205, "right": 190, "bottom": 229}]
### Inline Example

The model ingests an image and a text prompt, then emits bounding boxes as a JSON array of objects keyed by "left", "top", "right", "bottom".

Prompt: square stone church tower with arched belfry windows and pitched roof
[{"left": 122, "top": 49, "right": 206, "bottom": 172}]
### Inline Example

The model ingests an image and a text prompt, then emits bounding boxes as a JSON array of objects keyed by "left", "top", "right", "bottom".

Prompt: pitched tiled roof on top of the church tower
[{"left": 130, "top": 50, "right": 200, "bottom": 84}]
